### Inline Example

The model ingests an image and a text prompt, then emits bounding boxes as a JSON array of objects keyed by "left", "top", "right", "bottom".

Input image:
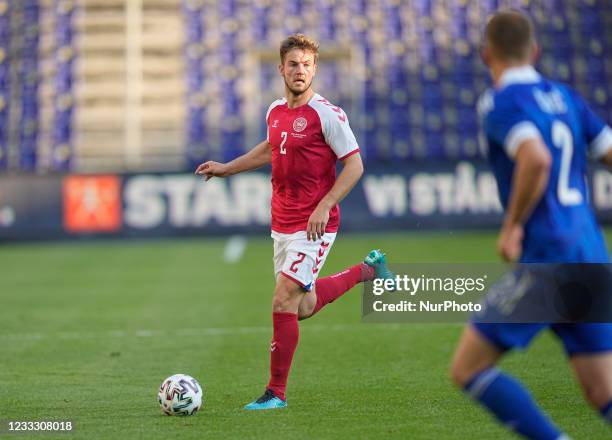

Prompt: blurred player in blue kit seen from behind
[{"left": 450, "top": 11, "right": 612, "bottom": 439}]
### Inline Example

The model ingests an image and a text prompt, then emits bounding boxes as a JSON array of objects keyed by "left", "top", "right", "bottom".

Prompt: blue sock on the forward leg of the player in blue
[{"left": 464, "top": 368, "right": 562, "bottom": 440}]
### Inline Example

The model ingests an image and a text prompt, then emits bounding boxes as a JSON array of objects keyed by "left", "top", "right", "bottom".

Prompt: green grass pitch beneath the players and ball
[{"left": 0, "top": 232, "right": 610, "bottom": 440}]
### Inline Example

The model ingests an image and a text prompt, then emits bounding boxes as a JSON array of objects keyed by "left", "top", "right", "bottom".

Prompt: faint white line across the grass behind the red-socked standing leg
[{"left": 0, "top": 324, "right": 404, "bottom": 341}]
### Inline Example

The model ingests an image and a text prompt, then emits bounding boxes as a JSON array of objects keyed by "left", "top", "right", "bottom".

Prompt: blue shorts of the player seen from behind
[{"left": 472, "top": 264, "right": 612, "bottom": 356}]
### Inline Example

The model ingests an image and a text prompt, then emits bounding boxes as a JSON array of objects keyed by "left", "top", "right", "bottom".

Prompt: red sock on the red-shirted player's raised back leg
[{"left": 311, "top": 263, "right": 375, "bottom": 316}]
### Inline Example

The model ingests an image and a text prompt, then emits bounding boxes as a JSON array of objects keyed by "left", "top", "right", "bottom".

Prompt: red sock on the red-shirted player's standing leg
[{"left": 268, "top": 312, "right": 300, "bottom": 400}]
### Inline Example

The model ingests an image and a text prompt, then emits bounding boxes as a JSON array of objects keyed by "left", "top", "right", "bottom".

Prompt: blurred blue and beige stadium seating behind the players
[{"left": 0, "top": 0, "right": 612, "bottom": 171}]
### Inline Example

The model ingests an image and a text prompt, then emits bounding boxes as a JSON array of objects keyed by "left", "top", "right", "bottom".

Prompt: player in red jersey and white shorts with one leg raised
[{"left": 196, "top": 34, "right": 394, "bottom": 409}]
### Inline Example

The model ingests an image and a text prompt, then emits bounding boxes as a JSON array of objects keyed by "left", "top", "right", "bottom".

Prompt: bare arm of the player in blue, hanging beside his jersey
[{"left": 497, "top": 137, "right": 552, "bottom": 262}]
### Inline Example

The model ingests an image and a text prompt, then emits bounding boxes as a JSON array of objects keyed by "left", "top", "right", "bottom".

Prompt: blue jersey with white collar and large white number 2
[{"left": 478, "top": 67, "right": 612, "bottom": 263}]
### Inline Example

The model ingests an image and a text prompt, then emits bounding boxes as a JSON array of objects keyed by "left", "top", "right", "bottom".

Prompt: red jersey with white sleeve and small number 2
[{"left": 266, "top": 94, "right": 359, "bottom": 234}]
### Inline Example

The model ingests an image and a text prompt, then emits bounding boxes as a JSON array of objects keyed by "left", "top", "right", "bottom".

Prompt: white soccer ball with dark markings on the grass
[{"left": 157, "top": 374, "right": 202, "bottom": 416}]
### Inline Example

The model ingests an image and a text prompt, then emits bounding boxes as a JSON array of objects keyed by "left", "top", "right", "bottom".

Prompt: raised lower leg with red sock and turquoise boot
[{"left": 299, "top": 249, "right": 395, "bottom": 319}]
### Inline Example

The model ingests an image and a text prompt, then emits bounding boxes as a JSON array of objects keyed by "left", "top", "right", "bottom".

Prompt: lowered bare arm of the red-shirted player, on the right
[{"left": 306, "top": 151, "right": 363, "bottom": 241}]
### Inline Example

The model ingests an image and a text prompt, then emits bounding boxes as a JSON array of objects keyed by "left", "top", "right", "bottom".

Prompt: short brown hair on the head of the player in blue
[{"left": 485, "top": 9, "right": 535, "bottom": 61}]
